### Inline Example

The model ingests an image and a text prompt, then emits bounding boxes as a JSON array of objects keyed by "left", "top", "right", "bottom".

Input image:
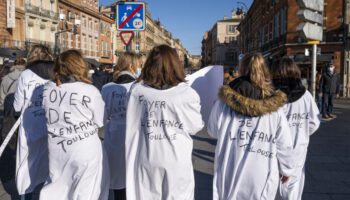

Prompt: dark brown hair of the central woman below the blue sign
[{"left": 139, "top": 45, "right": 185, "bottom": 89}]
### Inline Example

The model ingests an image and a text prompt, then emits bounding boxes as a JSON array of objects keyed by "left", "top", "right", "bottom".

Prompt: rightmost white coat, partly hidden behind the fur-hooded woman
[{"left": 279, "top": 91, "right": 320, "bottom": 200}]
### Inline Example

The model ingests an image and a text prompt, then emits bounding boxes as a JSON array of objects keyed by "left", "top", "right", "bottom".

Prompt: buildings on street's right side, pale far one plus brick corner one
[{"left": 202, "top": 0, "right": 350, "bottom": 97}]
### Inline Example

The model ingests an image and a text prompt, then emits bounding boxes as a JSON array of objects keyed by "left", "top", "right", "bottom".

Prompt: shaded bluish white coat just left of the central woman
[{"left": 101, "top": 82, "right": 133, "bottom": 190}]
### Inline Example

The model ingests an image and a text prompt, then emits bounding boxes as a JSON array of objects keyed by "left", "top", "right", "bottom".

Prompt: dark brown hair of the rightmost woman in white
[{"left": 272, "top": 57, "right": 301, "bottom": 79}]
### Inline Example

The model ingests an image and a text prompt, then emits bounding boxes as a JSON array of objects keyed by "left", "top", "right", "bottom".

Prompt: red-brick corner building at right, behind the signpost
[{"left": 239, "top": 0, "right": 346, "bottom": 96}]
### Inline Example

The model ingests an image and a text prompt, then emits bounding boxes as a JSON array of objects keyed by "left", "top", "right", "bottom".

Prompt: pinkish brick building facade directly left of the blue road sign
[{"left": 58, "top": 0, "right": 114, "bottom": 63}]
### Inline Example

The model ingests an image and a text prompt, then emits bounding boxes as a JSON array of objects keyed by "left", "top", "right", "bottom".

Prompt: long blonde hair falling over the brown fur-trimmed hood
[{"left": 239, "top": 53, "right": 274, "bottom": 98}]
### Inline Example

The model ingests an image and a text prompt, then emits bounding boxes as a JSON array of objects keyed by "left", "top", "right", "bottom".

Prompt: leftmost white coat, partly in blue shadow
[{"left": 13, "top": 69, "right": 48, "bottom": 195}]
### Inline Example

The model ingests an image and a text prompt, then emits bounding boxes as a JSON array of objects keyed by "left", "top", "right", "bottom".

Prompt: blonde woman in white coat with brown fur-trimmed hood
[{"left": 208, "top": 54, "right": 293, "bottom": 200}]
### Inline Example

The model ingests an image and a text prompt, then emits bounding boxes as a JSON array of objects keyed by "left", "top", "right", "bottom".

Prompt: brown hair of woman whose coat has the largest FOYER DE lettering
[{"left": 54, "top": 49, "right": 91, "bottom": 86}]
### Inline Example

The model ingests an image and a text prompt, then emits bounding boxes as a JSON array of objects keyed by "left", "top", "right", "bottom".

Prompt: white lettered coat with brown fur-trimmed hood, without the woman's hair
[{"left": 208, "top": 86, "right": 293, "bottom": 200}]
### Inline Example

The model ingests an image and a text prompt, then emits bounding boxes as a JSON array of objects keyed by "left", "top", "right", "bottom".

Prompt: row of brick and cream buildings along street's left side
[{"left": 0, "top": 0, "right": 192, "bottom": 64}]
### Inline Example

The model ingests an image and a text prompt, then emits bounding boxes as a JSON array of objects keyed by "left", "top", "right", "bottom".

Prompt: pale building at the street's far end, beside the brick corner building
[{"left": 202, "top": 12, "right": 242, "bottom": 68}]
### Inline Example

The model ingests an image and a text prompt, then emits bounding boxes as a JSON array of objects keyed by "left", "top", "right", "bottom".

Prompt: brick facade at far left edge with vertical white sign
[{"left": 0, "top": 0, "right": 25, "bottom": 49}]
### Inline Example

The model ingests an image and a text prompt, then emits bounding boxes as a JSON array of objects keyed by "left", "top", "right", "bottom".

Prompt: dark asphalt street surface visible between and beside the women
[{"left": 0, "top": 100, "right": 350, "bottom": 200}]
